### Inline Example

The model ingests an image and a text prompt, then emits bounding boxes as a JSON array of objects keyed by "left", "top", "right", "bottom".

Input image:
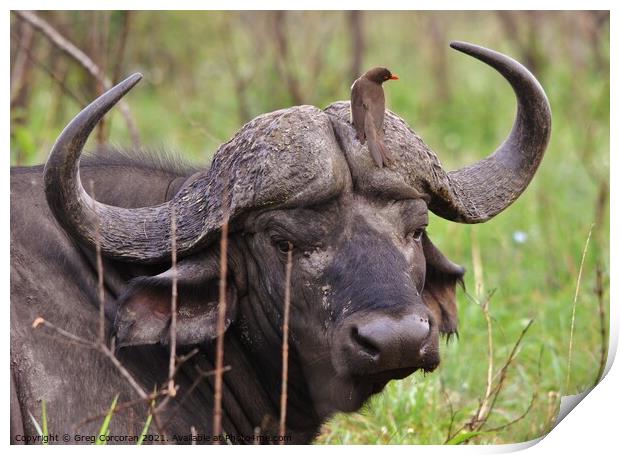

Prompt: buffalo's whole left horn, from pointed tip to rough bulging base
[{"left": 44, "top": 74, "right": 349, "bottom": 263}]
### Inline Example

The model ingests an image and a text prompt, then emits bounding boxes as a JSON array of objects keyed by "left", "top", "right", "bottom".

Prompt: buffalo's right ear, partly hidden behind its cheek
[{"left": 422, "top": 234, "right": 465, "bottom": 335}]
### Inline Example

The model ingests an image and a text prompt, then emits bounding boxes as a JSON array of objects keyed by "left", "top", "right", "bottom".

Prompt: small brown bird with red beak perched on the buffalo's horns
[{"left": 351, "top": 67, "right": 398, "bottom": 167}]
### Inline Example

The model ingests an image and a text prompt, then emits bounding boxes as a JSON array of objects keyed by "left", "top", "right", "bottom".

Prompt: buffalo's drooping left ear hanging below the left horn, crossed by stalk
[{"left": 114, "top": 255, "right": 237, "bottom": 348}]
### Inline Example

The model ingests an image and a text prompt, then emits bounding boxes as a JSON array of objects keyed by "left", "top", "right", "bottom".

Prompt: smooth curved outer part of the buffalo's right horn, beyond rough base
[{"left": 429, "top": 41, "right": 551, "bottom": 223}]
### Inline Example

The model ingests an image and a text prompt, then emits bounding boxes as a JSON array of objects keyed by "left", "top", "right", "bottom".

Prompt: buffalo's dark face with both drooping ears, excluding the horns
[{"left": 115, "top": 192, "right": 463, "bottom": 418}]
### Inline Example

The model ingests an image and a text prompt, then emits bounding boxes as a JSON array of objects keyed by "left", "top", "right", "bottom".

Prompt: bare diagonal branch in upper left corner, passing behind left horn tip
[{"left": 13, "top": 11, "right": 140, "bottom": 147}]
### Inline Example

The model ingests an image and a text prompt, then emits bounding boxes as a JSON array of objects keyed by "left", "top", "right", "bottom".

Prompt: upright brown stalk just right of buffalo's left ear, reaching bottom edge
[{"left": 213, "top": 213, "right": 228, "bottom": 445}]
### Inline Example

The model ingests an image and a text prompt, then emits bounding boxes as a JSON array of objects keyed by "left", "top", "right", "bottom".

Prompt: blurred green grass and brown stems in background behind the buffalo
[{"left": 11, "top": 11, "right": 610, "bottom": 444}]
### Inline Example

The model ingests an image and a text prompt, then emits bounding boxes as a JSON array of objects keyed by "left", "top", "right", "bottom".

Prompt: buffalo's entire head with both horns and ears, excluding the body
[{"left": 45, "top": 43, "right": 551, "bottom": 418}]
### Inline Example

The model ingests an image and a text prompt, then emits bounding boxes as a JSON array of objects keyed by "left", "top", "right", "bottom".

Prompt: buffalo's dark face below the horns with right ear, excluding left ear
[{"left": 238, "top": 196, "right": 463, "bottom": 417}]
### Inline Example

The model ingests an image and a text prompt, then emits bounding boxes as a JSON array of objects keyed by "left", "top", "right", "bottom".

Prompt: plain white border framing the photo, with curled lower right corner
[{"left": 0, "top": 0, "right": 620, "bottom": 454}]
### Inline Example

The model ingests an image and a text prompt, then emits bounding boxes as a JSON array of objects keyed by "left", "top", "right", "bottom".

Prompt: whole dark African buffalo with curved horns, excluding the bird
[{"left": 11, "top": 43, "right": 551, "bottom": 443}]
